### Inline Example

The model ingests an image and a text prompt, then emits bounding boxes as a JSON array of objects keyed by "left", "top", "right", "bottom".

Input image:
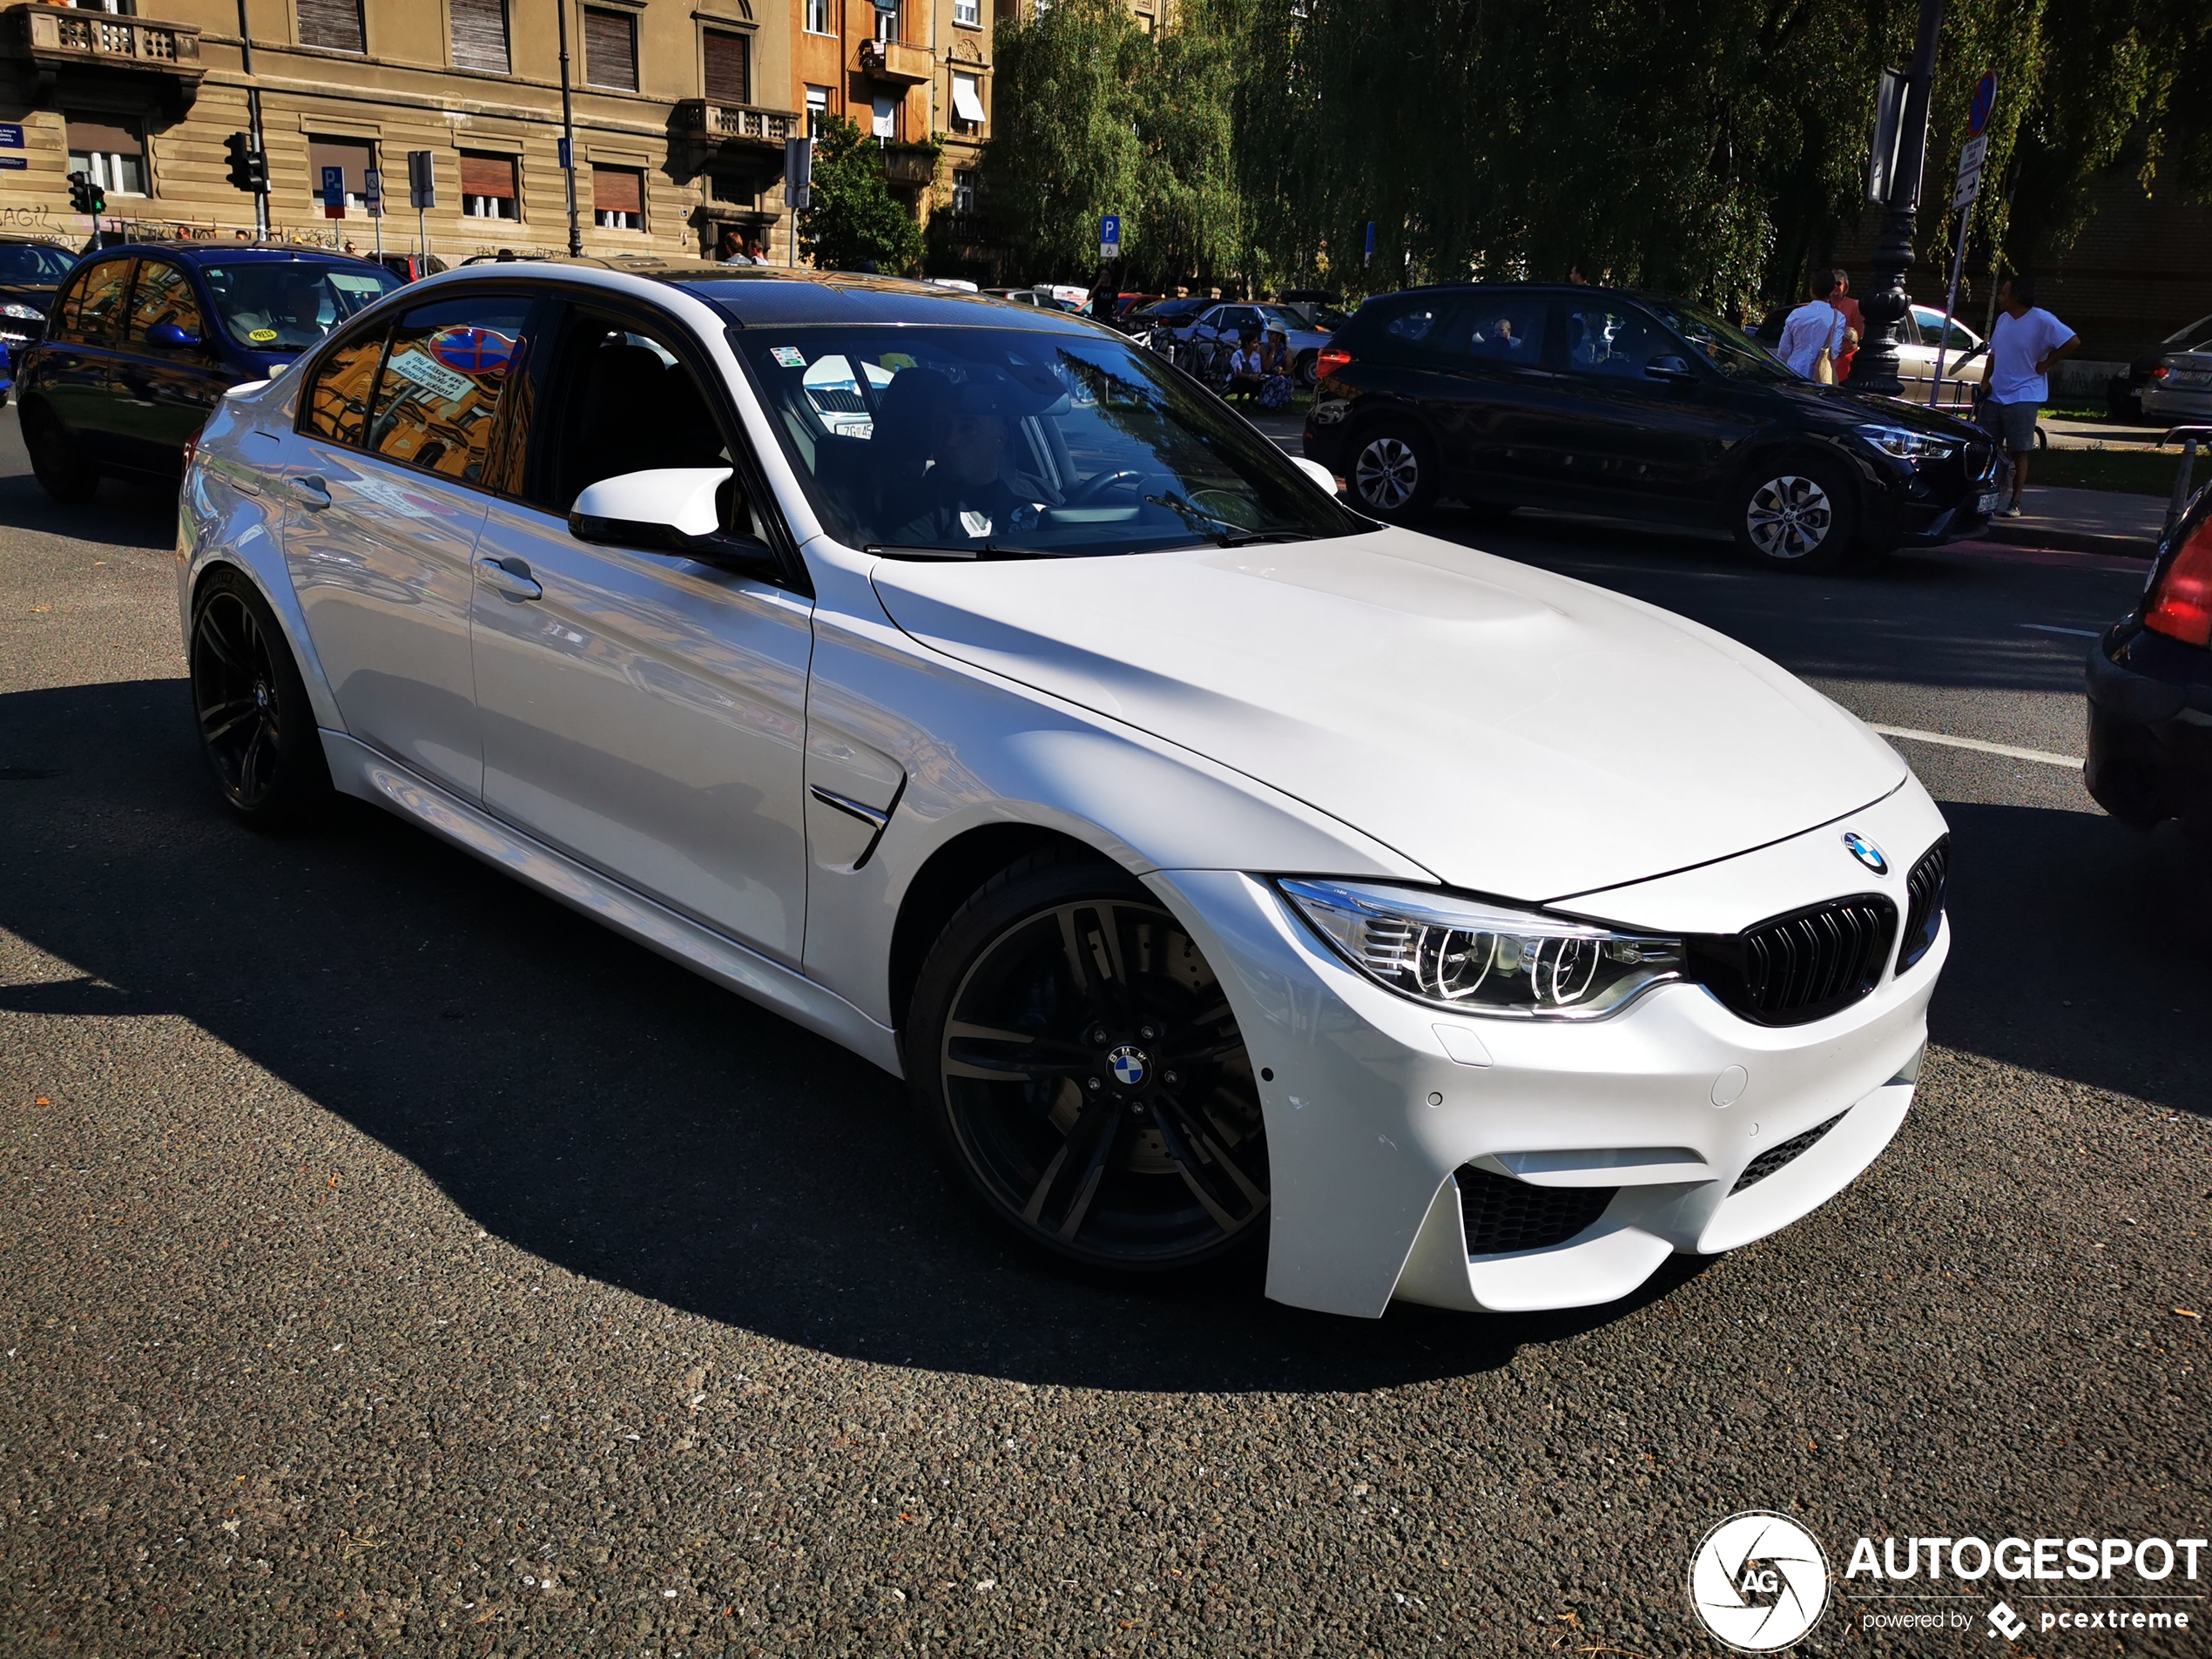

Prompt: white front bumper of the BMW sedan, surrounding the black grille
[{"left": 1152, "top": 781, "right": 1949, "bottom": 1316}]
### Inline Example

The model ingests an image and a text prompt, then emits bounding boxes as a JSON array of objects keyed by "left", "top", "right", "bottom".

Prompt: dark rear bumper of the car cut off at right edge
[{"left": 2081, "top": 624, "right": 2212, "bottom": 830}]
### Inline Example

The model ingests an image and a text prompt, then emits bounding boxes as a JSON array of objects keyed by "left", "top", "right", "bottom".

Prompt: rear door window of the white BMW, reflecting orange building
[{"left": 369, "top": 294, "right": 531, "bottom": 484}]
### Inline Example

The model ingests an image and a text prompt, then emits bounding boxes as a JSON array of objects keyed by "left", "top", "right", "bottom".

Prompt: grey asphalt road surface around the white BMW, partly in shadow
[{"left": 0, "top": 411, "right": 2212, "bottom": 1656}]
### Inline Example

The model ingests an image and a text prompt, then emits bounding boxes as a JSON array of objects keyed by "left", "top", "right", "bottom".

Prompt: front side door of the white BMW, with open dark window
[{"left": 474, "top": 312, "right": 814, "bottom": 967}]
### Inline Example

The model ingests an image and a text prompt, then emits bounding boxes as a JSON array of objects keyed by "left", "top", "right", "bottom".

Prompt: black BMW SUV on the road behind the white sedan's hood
[{"left": 1305, "top": 286, "right": 2006, "bottom": 570}]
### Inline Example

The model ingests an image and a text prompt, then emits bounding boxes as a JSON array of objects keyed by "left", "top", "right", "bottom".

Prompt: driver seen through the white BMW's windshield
[{"left": 876, "top": 368, "right": 1060, "bottom": 546}]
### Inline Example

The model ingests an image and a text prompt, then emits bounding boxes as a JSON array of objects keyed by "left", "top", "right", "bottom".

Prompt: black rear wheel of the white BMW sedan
[{"left": 190, "top": 566, "right": 329, "bottom": 830}]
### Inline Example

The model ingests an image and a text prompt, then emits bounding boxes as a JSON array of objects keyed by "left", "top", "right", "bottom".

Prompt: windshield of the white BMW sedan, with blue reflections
[{"left": 738, "top": 327, "right": 1365, "bottom": 557}]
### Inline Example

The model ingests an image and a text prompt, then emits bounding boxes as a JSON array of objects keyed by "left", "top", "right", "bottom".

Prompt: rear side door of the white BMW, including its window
[{"left": 283, "top": 294, "right": 531, "bottom": 800}]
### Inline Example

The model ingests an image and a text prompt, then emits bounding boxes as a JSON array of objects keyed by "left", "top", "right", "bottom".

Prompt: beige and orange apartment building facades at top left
[{"left": 0, "top": 0, "right": 924, "bottom": 263}]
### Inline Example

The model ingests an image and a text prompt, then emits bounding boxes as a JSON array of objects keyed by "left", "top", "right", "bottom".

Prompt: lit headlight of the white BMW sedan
[{"left": 1277, "top": 878, "right": 1688, "bottom": 1020}]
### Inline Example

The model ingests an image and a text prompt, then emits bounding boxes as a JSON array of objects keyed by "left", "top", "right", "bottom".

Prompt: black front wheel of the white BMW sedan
[{"left": 905, "top": 853, "right": 1267, "bottom": 1278}]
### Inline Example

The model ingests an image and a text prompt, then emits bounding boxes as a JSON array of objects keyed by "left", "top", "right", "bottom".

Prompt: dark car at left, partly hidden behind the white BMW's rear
[{"left": 16, "top": 243, "right": 401, "bottom": 502}]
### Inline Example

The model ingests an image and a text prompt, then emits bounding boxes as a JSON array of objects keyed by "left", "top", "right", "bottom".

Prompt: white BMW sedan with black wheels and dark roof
[{"left": 177, "top": 261, "right": 1949, "bottom": 1316}]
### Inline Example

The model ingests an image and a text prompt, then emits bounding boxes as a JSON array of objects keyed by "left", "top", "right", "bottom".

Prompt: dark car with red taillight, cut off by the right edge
[{"left": 2084, "top": 457, "right": 2212, "bottom": 840}]
